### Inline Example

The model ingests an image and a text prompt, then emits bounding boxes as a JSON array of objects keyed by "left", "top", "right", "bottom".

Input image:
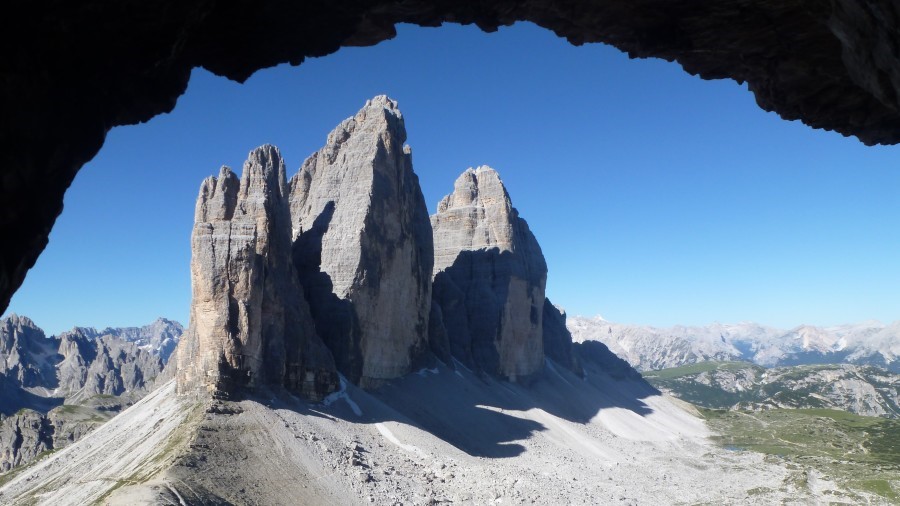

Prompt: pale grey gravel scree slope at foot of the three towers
[{"left": 0, "top": 363, "right": 828, "bottom": 505}]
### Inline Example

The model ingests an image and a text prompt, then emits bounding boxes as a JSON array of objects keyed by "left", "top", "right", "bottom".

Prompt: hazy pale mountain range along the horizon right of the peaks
[{"left": 567, "top": 316, "right": 900, "bottom": 373}]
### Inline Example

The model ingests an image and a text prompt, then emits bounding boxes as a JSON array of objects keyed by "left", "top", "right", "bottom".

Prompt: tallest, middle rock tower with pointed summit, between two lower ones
[{"left": 290, "top": 96, "right": 434, "bottom": 386}]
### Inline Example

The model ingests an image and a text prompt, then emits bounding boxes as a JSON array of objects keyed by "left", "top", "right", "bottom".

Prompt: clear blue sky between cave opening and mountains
[{"left": 7, "top": 24, "right": 900, "bottom": 333}]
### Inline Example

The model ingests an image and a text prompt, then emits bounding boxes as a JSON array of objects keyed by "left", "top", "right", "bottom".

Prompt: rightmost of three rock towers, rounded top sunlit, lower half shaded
[{"left": 431, "top": 167, "right": 547, "bottom": 380}]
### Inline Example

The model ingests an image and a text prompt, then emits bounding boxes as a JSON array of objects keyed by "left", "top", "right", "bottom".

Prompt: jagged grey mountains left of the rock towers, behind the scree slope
[{"left": 0, "top": 314, "right": 183, "bottom": 472}]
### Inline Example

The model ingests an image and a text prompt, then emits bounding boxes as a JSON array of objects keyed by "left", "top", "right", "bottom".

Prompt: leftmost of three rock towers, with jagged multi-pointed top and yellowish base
[{"left": 176, "top": 145, "right": 336, "bottom": 398}]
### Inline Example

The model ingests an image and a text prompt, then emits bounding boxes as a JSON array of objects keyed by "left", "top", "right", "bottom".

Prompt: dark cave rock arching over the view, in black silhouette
[{"left": 0, "top": 0, "right": 900, "bottom": 311}]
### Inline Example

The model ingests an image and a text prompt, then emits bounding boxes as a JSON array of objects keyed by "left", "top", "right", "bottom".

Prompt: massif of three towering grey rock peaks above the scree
[{"left": 176, "top": 96, "right": 577, "bottom": 400}]
